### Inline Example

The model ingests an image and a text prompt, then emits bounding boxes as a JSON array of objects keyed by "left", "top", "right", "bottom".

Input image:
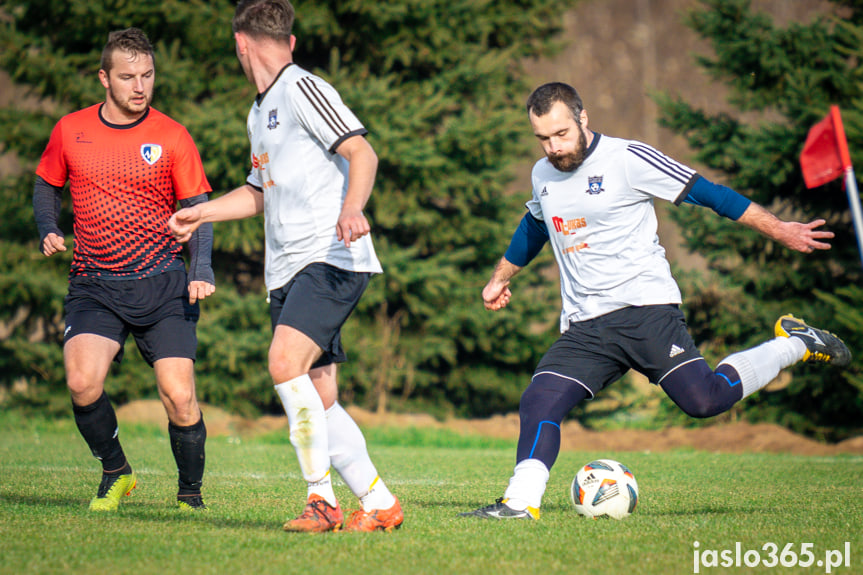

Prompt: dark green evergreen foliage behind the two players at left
[{"left": 0, "top": 0, "right": 574, "bottom": 415}]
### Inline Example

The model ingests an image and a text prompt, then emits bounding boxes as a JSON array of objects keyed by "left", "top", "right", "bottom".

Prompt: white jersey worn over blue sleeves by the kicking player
[{"left": 526, "top": 134, "right": 695, "bottom": 332}]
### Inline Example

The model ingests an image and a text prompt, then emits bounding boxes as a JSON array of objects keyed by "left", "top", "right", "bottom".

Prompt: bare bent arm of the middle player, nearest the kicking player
[{"left": 336, "top": 136, "right": 378, "bottom": 247}]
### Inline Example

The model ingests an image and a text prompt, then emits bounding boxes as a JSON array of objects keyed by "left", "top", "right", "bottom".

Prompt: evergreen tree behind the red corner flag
[{"left": 657, "top": 0, "right": 863, "bottom": 438}]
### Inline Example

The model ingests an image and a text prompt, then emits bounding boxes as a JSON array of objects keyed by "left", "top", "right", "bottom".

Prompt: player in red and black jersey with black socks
[{"left": 33, "top": 28, "right": 215, "bottom": 511}]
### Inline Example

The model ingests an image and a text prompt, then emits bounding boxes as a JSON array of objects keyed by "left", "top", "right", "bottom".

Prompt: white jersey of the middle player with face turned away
[{"left": 247, "top": 64, "right": 382, "bottom": 290}]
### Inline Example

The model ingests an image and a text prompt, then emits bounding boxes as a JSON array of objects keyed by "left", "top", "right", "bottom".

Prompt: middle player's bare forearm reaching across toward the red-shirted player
[{"left": 168, "top": 184, "right": 264, "bottom": 243}]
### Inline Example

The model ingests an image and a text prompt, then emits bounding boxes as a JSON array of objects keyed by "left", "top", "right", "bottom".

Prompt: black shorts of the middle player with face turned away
[{"left": 270, "top": 263, "right": 371, "bottom": 368}]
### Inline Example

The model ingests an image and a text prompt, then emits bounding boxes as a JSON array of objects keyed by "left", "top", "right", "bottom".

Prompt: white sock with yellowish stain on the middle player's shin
[{"left": 275, "top": 374, "right": 332, "bottom": 491}]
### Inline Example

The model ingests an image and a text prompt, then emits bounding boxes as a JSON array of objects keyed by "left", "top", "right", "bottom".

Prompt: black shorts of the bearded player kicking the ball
[{"left": 534, "top": 304, "right": 701, "bottom": 396}]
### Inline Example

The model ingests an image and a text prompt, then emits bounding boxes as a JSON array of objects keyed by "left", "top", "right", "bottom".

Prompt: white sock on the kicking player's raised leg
[{"left": 719, "top": 337, "right": 806, "bottom": 399}]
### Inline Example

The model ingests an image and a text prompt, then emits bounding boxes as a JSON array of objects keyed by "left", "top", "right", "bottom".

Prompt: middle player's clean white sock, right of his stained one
[{"left": 326, "top": 402, "right": 395, "bottom": 511}]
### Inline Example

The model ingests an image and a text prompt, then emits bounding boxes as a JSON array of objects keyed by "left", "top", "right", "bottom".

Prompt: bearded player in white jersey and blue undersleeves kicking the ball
[{"left": 461, "top": 83, "right": 851, "bottom": 520}]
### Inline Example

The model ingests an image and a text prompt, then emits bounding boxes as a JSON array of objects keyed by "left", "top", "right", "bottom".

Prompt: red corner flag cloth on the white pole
[{"left": 800, "top": 106, "right": 851, "bottom": 188}]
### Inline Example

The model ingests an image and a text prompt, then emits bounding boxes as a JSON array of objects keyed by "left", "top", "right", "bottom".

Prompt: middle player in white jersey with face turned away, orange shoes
[{"left": 169, "top": 0, "right": 404, "bottom": 532}]
